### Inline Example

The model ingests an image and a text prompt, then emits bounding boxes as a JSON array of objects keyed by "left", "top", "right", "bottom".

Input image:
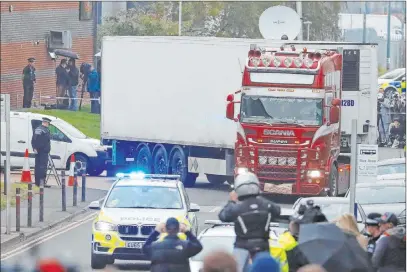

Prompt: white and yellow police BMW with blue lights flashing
[{"left": 89, "top": 173, "right": 200, "bottom": 269}]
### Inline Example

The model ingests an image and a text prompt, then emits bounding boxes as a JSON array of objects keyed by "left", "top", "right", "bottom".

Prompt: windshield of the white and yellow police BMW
[{"left": 105, "top": 186, "right": 183, "bottom": 209}]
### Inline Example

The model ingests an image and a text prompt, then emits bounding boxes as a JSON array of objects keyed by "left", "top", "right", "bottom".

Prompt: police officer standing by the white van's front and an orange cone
[{"left": 31, "top": 117, "right": 51, "bottom": 186}]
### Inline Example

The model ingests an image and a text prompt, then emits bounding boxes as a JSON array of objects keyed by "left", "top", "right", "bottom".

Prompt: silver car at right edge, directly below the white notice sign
[{"left": 345, "top": 180, "right": 406, "bottom": 218}]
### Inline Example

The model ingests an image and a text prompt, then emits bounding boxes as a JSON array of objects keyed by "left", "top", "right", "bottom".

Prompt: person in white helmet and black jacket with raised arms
[{"left": 219, "top": 172, "right": 281, "bottom": 259}]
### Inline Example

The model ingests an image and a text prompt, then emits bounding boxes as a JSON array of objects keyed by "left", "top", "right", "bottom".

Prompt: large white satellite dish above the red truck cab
[{"left": 259, "top": 6, "right": 301, "bottom": 40}]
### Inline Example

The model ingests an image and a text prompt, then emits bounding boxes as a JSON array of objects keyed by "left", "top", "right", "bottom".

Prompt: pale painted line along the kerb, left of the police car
[{"left": 1, "top": 212, "right": 97, "bottom": 261}]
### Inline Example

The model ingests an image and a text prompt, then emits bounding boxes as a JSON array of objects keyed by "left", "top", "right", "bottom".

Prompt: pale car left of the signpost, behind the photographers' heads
[{"left": 293, "top": 197, "right": 366, "bottom": 231}]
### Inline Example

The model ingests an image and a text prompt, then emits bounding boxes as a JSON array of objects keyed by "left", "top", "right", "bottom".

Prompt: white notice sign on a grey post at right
[{"left": 356, "top": 144, "right": 379, "bottom": 182}]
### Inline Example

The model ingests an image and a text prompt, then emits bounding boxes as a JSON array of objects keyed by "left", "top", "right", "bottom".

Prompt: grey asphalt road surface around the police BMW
[{"left": 1, "top": 178, "right": 291, "bottom": 271}]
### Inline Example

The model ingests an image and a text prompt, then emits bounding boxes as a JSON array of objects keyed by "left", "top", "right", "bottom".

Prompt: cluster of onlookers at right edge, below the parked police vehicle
[{"left": 377, "top": 89, "right": 406, "bottom": 148}]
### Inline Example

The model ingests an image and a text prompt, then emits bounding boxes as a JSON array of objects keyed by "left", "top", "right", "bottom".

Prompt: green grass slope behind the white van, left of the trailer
[{"left": 30, "top": 106, "right": 100, "bottom": 139}]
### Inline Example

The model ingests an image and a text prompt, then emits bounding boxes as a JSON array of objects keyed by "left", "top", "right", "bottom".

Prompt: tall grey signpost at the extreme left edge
[{"left": 0, "top": 94, "right": 11, "bottom": 234}]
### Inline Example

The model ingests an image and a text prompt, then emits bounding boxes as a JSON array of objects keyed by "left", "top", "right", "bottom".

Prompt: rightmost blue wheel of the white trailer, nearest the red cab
[{"left": 169, "top": 146, "right": 198, "bottom": 187}]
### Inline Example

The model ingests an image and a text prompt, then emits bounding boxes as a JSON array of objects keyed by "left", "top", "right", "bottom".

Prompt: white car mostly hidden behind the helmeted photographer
[{"left": 189, "top": 208, "right": 293, "bottom": 272}]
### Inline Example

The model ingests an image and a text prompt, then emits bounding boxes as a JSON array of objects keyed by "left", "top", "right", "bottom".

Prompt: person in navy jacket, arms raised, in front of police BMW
[{"left": 143, "top": 217, "right": 202, "bottom": 272}]
